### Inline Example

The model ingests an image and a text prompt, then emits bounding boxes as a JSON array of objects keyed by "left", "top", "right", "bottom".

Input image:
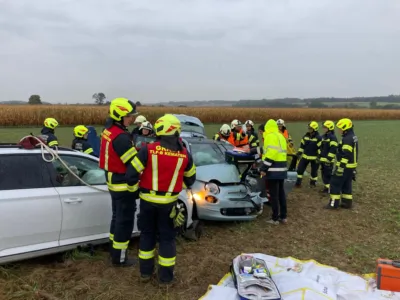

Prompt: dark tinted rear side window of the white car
[{"left": 0, "top": 154, "right": 53, "bottom": 191}]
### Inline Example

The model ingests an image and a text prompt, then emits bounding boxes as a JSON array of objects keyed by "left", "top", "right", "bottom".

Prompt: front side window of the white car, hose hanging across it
[{"left": 52, "top": 155, "right": 106, "bottom": 186}]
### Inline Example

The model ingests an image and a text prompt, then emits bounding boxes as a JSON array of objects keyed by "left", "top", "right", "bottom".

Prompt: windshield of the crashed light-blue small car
[{"left": 191, "top": 143, "right": 225, "bottom": 167}]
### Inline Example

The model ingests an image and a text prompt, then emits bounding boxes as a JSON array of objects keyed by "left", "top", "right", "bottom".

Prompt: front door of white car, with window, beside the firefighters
[{"left": 47, "top": 153, "right": 137, "bottom": 246}]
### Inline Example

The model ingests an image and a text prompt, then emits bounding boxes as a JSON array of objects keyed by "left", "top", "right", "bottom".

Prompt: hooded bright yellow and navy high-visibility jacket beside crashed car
[{"left": 261, "top": 119, "right": 287, "bottom": 179}]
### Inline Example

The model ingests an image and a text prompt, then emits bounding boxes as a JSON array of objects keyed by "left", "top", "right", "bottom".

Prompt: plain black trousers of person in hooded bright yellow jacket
[{"left": 267, "top": 179, "right": 287, "bottom": 221}]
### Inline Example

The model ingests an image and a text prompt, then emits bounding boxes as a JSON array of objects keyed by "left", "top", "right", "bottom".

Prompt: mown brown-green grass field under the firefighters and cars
[{"left": 0, "top": 121, "right": 400, "bottom": 300}]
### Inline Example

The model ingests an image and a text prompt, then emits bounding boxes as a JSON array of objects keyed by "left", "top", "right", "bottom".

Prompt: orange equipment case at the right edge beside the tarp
[{"left": 376, "top": 258, "right": 400, "bottom": 292}]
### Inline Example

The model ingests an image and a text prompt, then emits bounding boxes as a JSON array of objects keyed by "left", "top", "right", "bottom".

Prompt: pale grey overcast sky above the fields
[{"left": 0, "top": 0, "right": 400, "bottom": 103}]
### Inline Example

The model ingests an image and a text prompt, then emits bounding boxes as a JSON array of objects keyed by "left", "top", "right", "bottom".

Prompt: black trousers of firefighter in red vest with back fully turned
[{"left": 139, "top": 199, "right": 177, "bottom": 283}]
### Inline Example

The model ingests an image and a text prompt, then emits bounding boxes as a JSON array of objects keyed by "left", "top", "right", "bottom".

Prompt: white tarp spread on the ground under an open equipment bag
[{"left": 200, "top": 253, "right": 400, "bottom": 300}]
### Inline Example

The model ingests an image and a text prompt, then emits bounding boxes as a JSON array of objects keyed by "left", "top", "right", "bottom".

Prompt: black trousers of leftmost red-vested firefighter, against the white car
[{"left": 110, "top": 191, "right": 138, "bottom": 264}]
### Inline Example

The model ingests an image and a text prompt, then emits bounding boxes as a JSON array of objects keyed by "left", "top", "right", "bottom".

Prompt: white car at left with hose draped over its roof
[{"left": 0, "top": 144, "right": 198, "bottom": 264}]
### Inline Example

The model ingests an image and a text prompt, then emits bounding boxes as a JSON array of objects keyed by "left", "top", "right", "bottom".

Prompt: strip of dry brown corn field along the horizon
[{"left": 0, "top": 105, "right": 400, "bottom": 126}]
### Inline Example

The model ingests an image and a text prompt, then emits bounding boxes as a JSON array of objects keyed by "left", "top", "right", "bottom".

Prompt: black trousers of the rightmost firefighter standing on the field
[{"left": 330, "top": 169, "right": 353, "bottom": 208}]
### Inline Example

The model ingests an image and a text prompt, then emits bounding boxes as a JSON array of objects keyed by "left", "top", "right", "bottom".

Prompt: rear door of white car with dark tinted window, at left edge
[{"left": 0, "top": 153, "right": 62, "bottom": 262}]
